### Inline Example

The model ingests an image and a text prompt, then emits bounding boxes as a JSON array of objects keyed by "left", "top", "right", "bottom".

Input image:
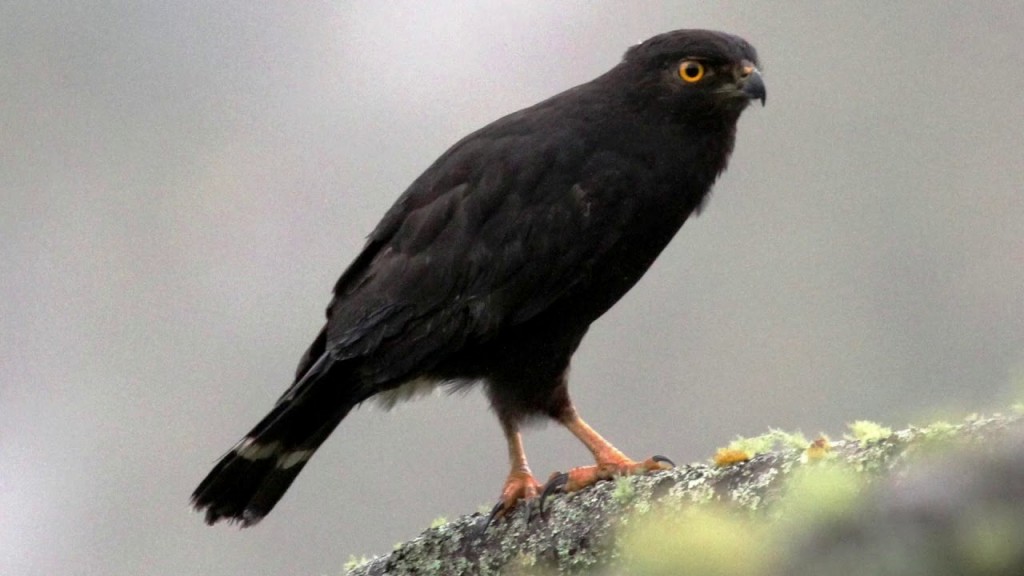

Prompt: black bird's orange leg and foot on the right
[{"left": 549, "top": 408, "right": 672, "bottom": 492}]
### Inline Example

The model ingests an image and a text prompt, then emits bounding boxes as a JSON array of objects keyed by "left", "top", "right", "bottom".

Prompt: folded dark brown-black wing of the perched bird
[{"left": 327, "top": 119, "right": 639, "bottom": 387}]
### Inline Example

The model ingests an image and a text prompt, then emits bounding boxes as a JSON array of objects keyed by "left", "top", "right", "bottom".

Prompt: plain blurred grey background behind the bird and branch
[{"left": 0, "top": 1, "right": 1024, "bottom": 575}]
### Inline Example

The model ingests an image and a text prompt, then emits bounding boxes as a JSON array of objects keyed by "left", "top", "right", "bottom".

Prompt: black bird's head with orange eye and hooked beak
[{"left": 617, "top": 30, "right": 766, "bottom": 122}]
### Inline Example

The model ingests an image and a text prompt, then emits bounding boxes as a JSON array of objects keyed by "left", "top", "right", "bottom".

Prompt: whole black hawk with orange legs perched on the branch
[{"left": 191, "top": 30, "right": 766, "bottom": 527}]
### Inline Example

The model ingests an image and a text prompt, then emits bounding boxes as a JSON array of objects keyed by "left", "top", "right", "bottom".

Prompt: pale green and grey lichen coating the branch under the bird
[{"left": 345, "top": 407, "right": 1024, "bottom": 576}]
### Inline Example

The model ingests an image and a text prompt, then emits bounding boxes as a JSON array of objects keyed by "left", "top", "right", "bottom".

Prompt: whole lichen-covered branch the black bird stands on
[{"left": 348, "top": 415, "right": 1024, "bottom": 576}]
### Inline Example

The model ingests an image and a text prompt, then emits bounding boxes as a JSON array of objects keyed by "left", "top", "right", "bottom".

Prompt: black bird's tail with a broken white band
[{"left": 191, "top": 354, "right": 358, "bottom": 527}]
